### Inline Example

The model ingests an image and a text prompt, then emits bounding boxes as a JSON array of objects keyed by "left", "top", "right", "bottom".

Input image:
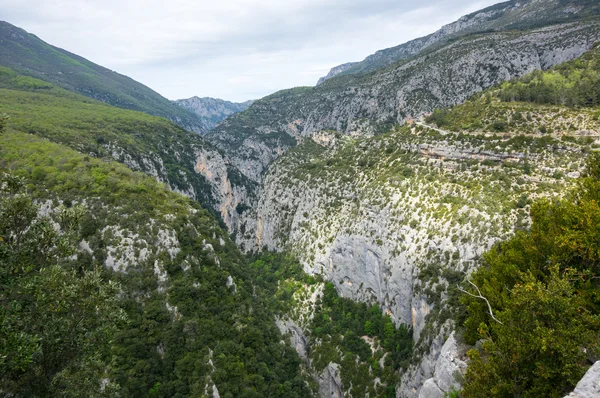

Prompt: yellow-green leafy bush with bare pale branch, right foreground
[{"left": 462, "top": 153, "right": 600, "bottom": 397}]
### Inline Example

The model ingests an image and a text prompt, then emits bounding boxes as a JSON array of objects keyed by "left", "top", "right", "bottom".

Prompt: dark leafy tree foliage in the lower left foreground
[{"left": 0, "top": 174, "right": 125, "bottom": 397}]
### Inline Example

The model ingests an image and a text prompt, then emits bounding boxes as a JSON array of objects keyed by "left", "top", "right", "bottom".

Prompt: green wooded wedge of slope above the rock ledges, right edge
[{"left": 426, "top": 46, "right": 600, "bottom": 134}]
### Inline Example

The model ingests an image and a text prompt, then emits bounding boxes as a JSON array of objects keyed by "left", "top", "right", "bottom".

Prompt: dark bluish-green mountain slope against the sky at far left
[{"left": 0, "top": 21, "right": 207, "bottom": 133}]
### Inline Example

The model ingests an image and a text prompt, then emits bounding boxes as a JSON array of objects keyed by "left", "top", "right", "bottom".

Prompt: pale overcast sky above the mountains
[{"left": 0, "top": 0, "right": 499, "bottom": 102}]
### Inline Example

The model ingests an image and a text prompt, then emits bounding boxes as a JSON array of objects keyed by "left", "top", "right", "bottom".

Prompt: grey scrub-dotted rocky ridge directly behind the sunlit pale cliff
[{"left": 208, "top": 19, "right": 600, "bottom": 181}]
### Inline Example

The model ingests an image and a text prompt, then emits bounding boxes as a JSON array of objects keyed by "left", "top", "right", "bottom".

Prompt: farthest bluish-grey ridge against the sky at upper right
[{"left": 317, "top": 0, "right": 600, "bottom": 85}]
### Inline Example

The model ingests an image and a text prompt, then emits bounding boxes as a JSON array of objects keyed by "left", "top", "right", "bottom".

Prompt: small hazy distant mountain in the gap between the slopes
[{"left": 174, "top": 97, "right": 254, "bottom": 130}]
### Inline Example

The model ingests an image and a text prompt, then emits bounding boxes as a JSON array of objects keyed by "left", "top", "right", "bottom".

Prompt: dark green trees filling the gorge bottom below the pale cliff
[{"left": 250, "top": 252, "right": 412, "bottom": 397}]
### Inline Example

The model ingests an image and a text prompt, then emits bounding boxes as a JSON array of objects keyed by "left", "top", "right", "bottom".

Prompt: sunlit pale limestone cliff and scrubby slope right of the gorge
[{"left": 237, "top": 49, "right": 600, "bottom": 397}]
